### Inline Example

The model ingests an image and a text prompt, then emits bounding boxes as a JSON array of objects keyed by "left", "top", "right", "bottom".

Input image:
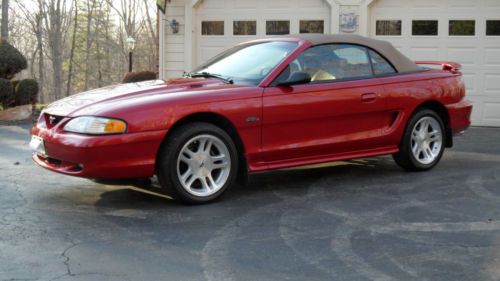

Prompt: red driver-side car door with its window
[{"left": 262, "top": 44, "right": 393, "bottom": 164}]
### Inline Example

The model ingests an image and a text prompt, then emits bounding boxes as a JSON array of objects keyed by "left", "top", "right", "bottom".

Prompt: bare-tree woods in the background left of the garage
[{"left": 8, "top": 0, "right": 158, "bottom": 103}]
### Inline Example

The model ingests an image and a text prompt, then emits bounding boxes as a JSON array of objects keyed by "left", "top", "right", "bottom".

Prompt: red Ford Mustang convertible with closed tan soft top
[{"left": 30, "top": 35, "right": 472, "bottom": 203}]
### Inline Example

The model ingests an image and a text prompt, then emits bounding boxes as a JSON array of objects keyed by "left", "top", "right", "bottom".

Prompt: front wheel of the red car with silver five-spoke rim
[{"left": 156, "top": 122, "right": 238, "bottom": 204}]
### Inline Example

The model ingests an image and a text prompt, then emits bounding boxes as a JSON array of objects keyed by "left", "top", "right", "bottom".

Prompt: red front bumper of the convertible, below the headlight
[{"left": 32, "top": 125, "right": 167, "bottom": 179}]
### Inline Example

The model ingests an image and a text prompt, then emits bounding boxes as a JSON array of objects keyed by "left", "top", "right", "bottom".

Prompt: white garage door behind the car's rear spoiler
[{"left": 370, "top": 0, "right": 500, "bottom": 126}]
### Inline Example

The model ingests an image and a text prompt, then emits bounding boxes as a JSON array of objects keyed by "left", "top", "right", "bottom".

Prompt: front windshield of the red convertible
[{"left": 189, "top": 42, "right": 298, "bottom": 85}]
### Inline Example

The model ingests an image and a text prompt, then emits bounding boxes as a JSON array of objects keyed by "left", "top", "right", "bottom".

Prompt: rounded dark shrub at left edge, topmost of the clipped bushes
[{"left": 0, "top": 42, "right": 28, "bottom": 80}]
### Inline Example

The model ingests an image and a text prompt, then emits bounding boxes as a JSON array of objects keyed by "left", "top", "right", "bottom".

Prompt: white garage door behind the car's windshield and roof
[{"left": 194, "top": 0, "right": 330, "bottom": 65}]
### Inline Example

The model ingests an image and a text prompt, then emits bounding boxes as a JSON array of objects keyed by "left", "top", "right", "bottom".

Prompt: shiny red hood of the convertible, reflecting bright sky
[{"left": 44, "top": 78, "right": 232, "bottom": 116}]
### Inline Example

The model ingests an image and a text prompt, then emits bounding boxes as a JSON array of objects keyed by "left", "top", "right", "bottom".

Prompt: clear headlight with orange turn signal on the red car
[{"left": 64, "top": 116, "right": 127, "bottom": 135}]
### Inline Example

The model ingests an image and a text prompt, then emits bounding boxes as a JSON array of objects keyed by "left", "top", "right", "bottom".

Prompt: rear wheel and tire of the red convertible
[{"left": 393, "top": 109, "right": 446, "bottom": 171}]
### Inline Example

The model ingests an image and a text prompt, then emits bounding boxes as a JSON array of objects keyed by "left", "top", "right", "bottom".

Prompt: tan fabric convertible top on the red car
[{"left": 286, "top": 34, "right": 420, "bottom": 72}]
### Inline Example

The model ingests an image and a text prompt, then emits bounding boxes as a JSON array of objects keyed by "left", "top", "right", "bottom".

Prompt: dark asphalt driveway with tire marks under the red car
[{"left": 0, "top": 125, "right": 500, "bottom": 281}]
